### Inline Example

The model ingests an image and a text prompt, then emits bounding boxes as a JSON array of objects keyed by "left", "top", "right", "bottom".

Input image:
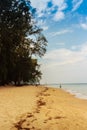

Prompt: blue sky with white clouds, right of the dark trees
[{"left": 31, "top": 0, "right": 87, "bottom": 83}]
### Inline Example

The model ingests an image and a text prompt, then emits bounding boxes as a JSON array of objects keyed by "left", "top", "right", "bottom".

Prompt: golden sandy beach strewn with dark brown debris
[{"left": 0, "top": 86, "right": 87, "bottom": 130}]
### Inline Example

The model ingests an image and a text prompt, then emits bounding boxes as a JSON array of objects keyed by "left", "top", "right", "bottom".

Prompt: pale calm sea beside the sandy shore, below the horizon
[{"left": 48, "top": 83, "right": 87, "bottom": 99}]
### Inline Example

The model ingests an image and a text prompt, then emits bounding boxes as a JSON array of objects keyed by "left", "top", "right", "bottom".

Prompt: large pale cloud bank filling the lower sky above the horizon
[{"left": 41, "top": 44, "right": 87, "bottom": 83}]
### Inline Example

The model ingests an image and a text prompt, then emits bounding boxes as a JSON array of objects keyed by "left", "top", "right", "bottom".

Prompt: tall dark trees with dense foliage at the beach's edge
[{"left": 0, "top": 0, "right": 47, "bottom": 85}]
